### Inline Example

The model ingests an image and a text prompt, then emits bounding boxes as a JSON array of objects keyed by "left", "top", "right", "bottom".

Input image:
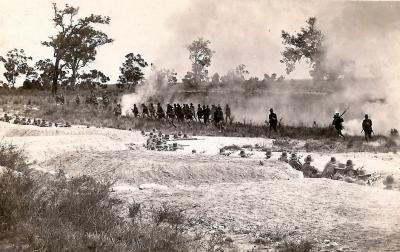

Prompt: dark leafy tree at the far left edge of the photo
[{"left": 0, "top": 48, "right": 32, "bottom": 87}]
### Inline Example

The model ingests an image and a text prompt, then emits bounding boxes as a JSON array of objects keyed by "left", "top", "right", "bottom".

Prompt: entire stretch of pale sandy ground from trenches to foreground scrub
[{"left": 0, "top": 122, "right": 400, "bottom": 251}]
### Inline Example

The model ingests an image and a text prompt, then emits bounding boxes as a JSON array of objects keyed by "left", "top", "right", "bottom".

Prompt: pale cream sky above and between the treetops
[{"left": 0, "top": 0, "right": 398, "bottom": 82}]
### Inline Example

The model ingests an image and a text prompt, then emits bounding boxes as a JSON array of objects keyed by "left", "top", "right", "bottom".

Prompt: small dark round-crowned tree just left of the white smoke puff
[{"left": 118, "top": 53, "right": 148, "bottom": 88}]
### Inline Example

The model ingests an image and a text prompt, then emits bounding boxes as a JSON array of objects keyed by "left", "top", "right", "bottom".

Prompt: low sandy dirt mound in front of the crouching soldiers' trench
[{"left": 41, "top": 150, "right": 302, "bottom": 185}]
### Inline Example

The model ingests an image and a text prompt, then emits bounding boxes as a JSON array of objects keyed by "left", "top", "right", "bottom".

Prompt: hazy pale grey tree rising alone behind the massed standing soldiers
[{"left": 184, "top": 38, "right": 215, "bottom": 85}]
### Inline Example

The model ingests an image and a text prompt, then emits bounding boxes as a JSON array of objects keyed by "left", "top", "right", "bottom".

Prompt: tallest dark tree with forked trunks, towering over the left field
[{"left": 42, "top": 3, "right": 112, "bottom": 93}]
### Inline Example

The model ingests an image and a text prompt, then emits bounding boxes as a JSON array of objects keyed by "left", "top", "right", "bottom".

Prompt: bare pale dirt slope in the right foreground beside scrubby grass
[{"left": 116, "top": 179, "right": 400, "bottom": 251}]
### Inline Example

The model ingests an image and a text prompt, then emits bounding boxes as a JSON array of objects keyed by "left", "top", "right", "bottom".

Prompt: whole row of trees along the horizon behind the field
[{"left": 0, "top": 3, "right": 345, "bottom": 94}]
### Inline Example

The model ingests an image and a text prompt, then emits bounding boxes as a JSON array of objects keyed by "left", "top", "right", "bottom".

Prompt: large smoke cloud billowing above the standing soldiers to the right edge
[{"left": 121, "top": 1, "right": 400, "bottom": 134}]
